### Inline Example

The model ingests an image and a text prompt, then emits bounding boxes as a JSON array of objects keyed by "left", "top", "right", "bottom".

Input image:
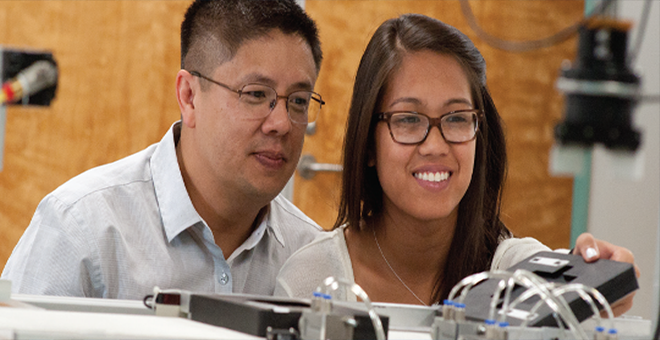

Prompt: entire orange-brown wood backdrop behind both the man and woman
[{"left": 0, "top": 0, "right": 583, "bottom": 267}]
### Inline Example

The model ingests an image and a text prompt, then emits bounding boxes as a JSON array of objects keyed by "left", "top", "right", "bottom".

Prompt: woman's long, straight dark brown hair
[{"left": 334, "top": 14, "right": 509, "bottom": 302}]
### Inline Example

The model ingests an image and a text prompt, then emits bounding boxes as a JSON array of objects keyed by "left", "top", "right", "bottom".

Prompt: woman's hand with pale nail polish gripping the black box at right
[{"left": 573, "top": 233, "right": 639, "bottom": 317}]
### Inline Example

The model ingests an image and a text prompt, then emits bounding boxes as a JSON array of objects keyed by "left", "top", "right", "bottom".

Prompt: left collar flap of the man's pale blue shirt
[{"left": 150, "top": 121, "right": 204, "bottom": 242}]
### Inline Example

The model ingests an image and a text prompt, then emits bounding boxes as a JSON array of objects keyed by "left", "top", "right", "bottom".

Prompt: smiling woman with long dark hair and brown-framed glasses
[{"left": 275, "top": 14, "right": 633, "bottom": 312}]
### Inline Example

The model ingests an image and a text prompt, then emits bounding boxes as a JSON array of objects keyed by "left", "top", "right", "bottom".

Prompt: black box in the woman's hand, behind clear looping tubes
[{"left": 458, "top": 252, "right": 639, "bottom": 327}]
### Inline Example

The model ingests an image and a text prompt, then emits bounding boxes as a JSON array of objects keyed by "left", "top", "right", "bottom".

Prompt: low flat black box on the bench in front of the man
[{"left": 189, "top": 294, "right": 388, "bottom": 339}]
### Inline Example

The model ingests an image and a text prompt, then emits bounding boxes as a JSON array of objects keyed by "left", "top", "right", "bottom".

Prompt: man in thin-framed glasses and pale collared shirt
[{"left": 2, "top": 0, "right": 323, "bottom": 299}]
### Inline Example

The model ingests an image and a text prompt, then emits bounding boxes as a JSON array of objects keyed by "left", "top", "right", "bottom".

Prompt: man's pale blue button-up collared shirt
[{"left": 2, "top": 123, "right": 321, "bottom": 299}]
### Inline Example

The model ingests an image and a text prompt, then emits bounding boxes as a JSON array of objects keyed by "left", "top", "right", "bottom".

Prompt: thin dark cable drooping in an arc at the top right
[{"left": 460, "top": 0, "right": 614, "bottom": 52}]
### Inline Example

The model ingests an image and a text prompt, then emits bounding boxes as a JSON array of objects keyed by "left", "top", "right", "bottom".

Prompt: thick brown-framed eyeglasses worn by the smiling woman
[{"left": 378, "top": 110, "right": 482, "bottom": 145}]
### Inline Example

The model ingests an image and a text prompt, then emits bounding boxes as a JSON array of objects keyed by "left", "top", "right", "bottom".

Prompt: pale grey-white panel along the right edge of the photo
[{"left": 588, "top": 0, "right": 660, "bottom": 319}]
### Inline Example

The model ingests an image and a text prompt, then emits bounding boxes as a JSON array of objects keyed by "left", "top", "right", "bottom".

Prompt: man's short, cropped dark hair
[{"left": 181, "top": 0, "right": 323, "bottom": 72}]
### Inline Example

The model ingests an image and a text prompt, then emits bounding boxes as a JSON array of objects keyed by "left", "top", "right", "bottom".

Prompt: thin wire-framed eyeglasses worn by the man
[{"left": 189, "top": 71, "right": 325, "bottom": 124}]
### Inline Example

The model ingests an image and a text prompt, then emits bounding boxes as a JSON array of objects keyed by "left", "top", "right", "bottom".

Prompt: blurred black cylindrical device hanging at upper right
[{"left": 555, "top": 18, "right": 641, "bottom": 151}]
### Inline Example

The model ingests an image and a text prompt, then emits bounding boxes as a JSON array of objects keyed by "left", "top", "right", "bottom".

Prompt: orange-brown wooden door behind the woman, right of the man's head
[{"left": 294, "top": 0, "right": 584, "bottom": 247}]
